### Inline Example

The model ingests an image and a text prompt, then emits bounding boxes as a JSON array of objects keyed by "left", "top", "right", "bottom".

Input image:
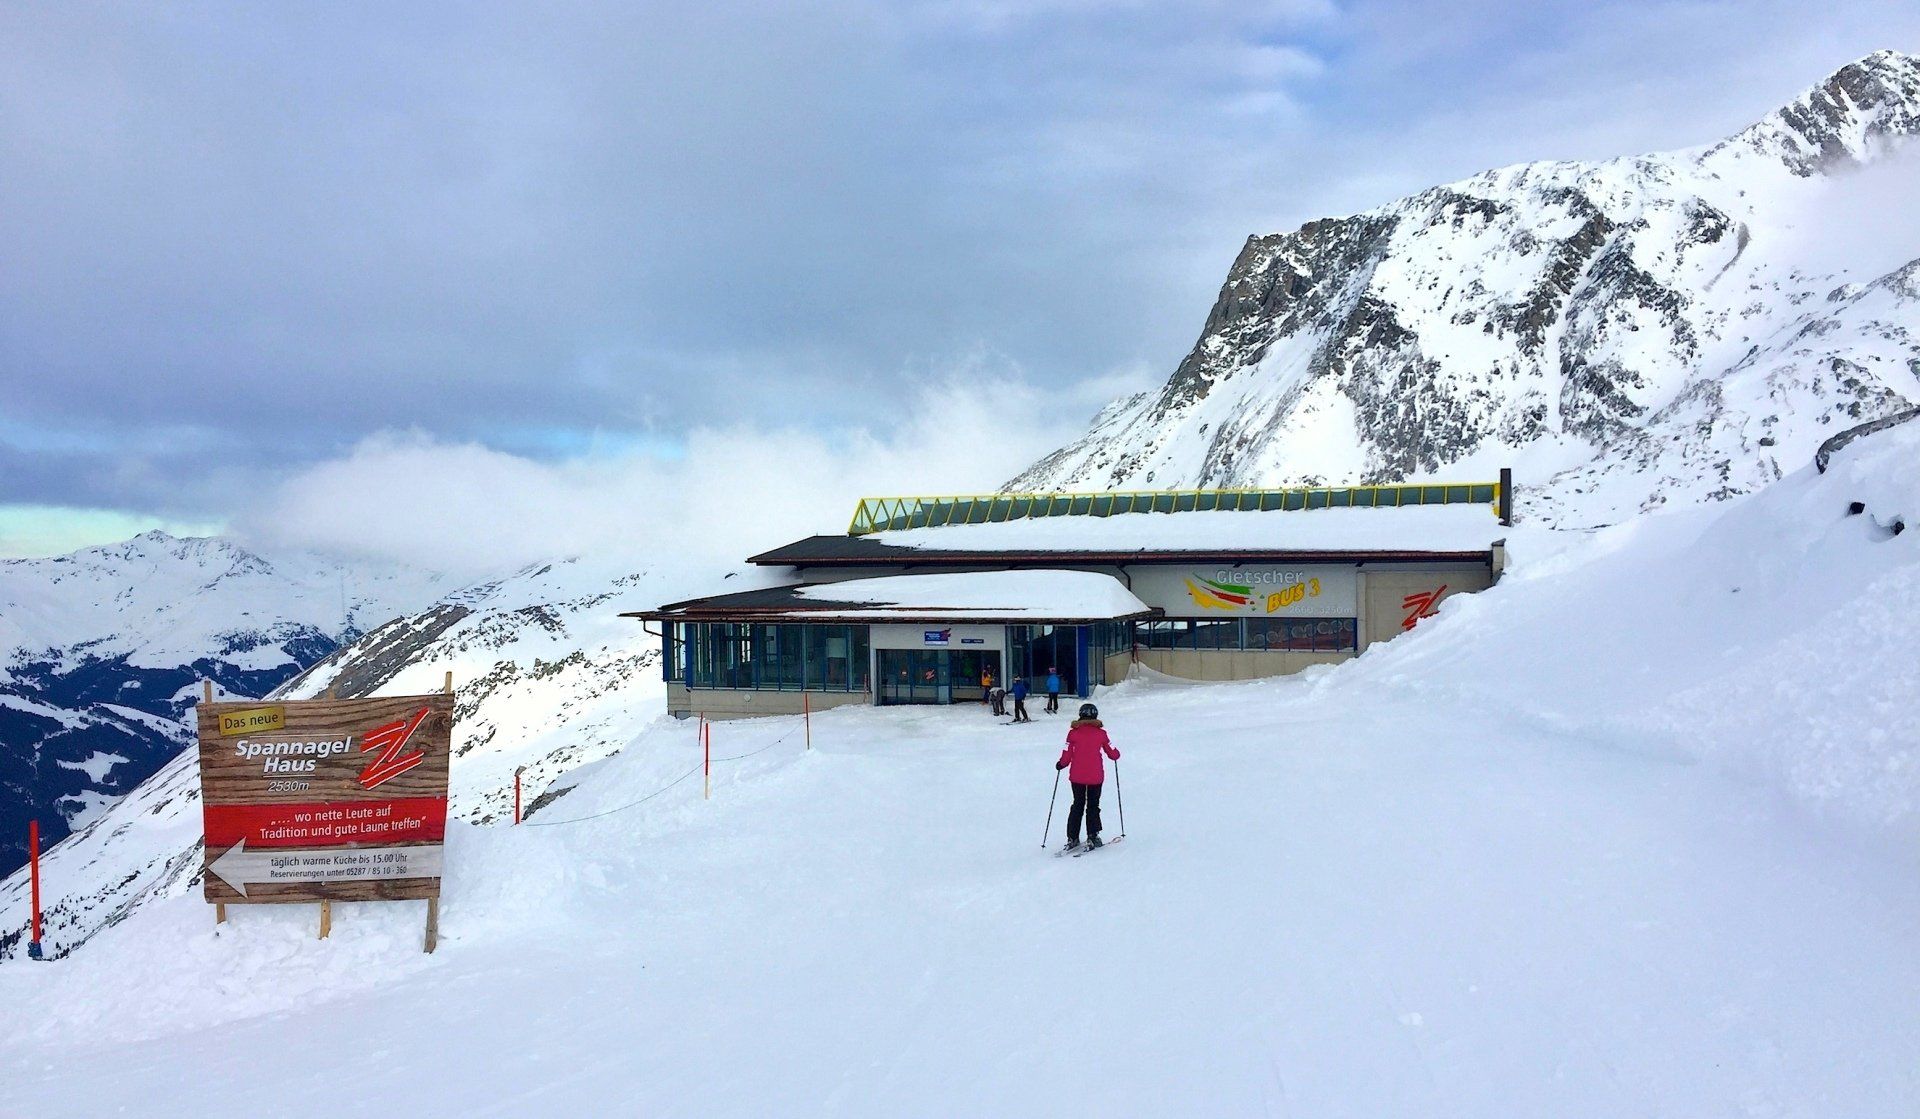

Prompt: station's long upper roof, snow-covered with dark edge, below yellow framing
[{"left": 749, "top": 505, "right": 1505, "bottom": 566}]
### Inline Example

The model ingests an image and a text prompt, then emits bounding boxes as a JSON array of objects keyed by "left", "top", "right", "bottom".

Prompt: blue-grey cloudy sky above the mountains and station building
[{"left": 0, "top": 0, "right": 1920, "bottom": 562}]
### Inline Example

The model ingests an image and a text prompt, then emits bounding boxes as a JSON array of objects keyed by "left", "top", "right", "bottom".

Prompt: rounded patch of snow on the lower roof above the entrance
[{"left": 793, "top": 570, "right": 1150, "bottom": 620}]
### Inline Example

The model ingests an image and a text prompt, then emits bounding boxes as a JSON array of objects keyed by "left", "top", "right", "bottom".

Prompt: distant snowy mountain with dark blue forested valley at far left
[{"left": 0, "top": 532, "right": 444, "bottom": 873}]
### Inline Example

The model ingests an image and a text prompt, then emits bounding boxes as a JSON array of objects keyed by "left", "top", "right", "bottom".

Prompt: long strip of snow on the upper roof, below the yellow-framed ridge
[{"left": 864, "top": 505, "right": 1507, "bottom": 551}]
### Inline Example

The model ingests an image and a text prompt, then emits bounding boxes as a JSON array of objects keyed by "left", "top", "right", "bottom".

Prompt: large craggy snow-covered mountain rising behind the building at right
[{"left": 1008, "top": 52, "right": 1920, "bottom": 524}]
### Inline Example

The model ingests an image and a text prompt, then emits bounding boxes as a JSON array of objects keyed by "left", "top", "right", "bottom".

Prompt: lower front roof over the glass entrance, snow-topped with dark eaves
[{"left": 624, "top": 570, "right": 1154, "bottom": 624}]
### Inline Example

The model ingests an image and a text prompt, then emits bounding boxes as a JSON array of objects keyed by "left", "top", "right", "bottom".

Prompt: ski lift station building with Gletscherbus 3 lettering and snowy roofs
[{"left": 630, "top": 470, "right": 1513, "bottom": 718}]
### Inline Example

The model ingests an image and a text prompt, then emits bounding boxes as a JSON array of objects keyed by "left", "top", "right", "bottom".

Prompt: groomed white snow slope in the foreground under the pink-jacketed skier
[{"left": 0, "top": 416, "right": 1920, "bottom": 1119}]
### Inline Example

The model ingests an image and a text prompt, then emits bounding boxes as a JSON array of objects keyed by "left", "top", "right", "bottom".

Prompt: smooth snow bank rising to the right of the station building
[{"left": 1340, "top": 426, "right": 1920, "bottom": 843}]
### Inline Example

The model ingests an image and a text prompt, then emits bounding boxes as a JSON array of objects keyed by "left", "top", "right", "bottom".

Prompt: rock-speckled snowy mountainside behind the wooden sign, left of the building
[{"left": 0, "top": 560, "right": 725, "bottom": 960}]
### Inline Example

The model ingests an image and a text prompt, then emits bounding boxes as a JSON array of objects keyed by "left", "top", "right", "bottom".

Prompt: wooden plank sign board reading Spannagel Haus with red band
[{"left": 198, "top": 693, "right": 453, "bottom": 904}]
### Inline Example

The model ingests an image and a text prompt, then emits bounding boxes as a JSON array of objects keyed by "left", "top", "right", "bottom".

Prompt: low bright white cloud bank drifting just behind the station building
[{"left": 238, "top": 374, "right": 1087, "bottom": 578}]
